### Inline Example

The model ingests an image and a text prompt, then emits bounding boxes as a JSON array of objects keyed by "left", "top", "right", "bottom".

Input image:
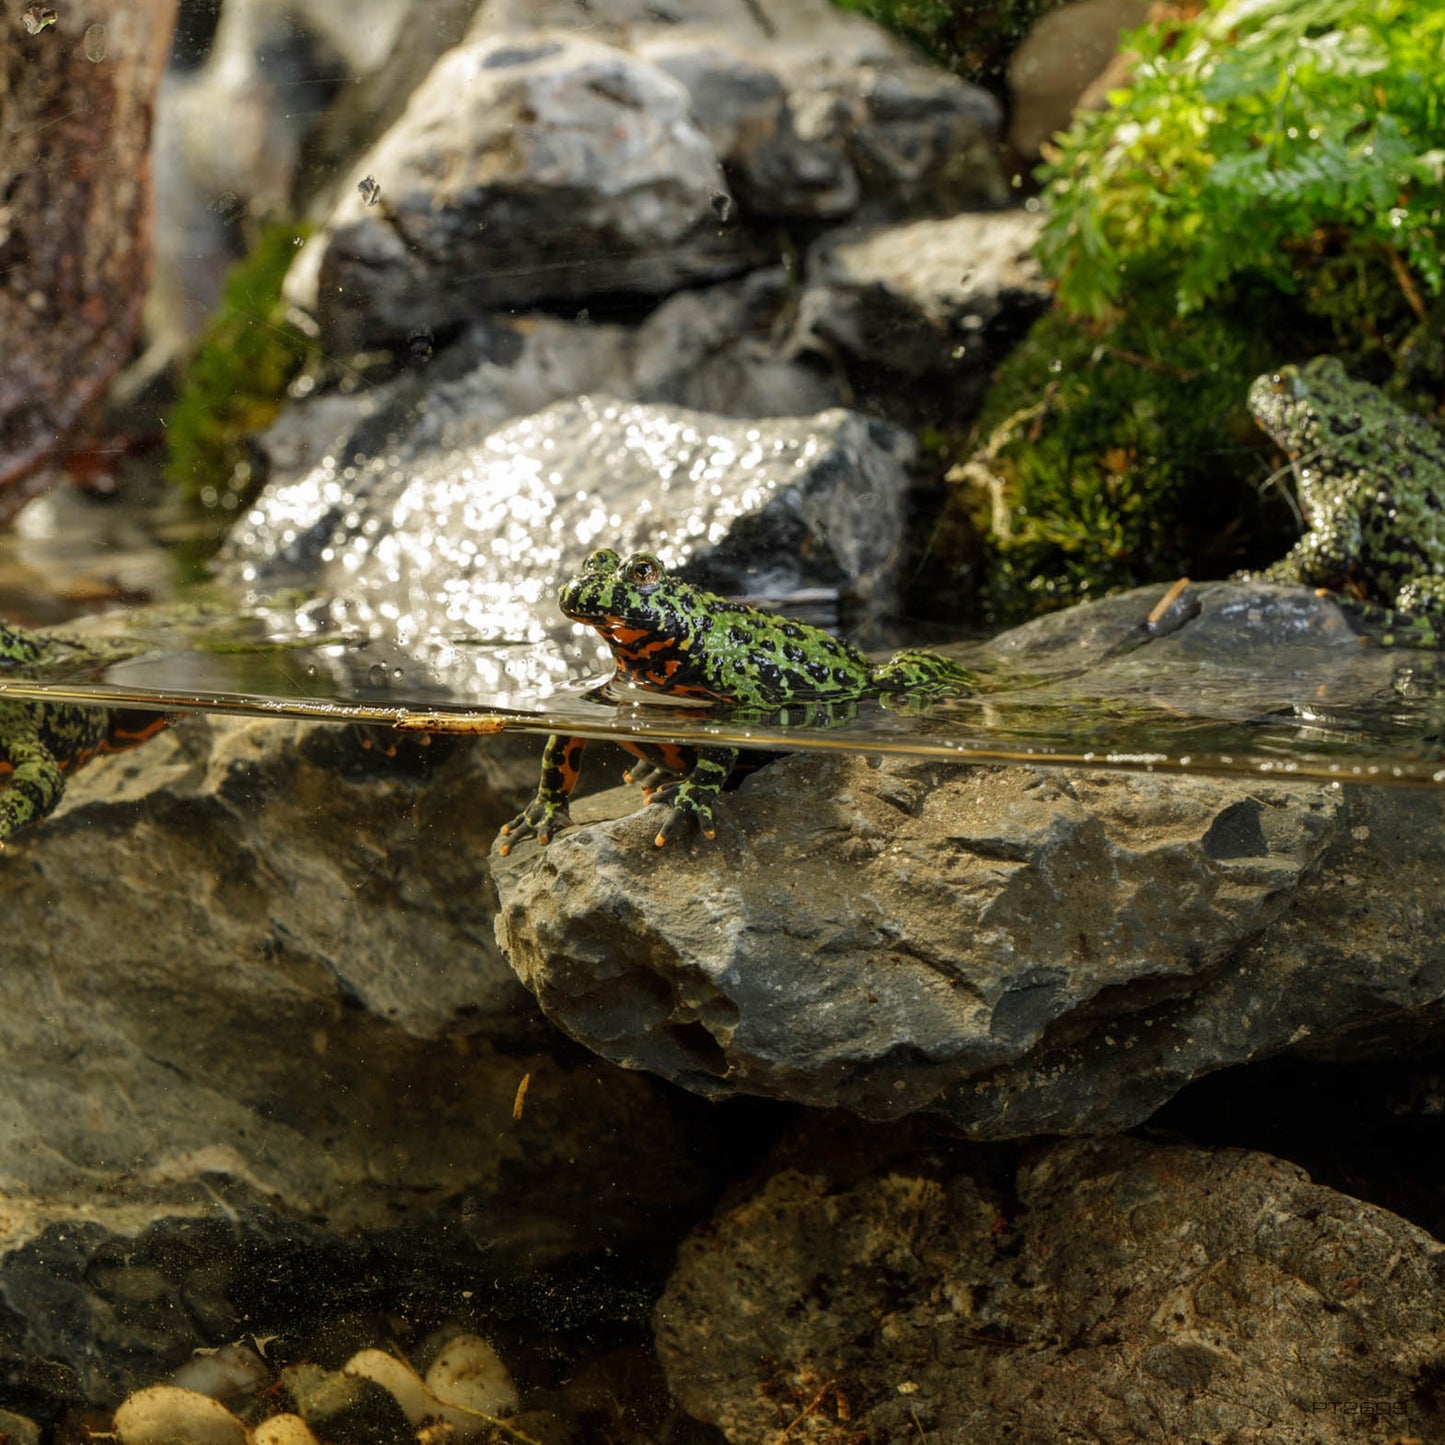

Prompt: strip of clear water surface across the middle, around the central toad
[{"left": 0, "top": 604, "right": 1445, "bottom": 788}]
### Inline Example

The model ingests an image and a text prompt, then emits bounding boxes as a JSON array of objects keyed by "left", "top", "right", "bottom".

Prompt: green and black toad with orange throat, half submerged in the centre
[{"left": 499, "top": 548, "right": 974, "bottom": 855}]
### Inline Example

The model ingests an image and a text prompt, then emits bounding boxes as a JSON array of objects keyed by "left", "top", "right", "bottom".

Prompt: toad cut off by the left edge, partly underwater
[{"left": 0, "top": 623, "right": 166, "bottom": 848}]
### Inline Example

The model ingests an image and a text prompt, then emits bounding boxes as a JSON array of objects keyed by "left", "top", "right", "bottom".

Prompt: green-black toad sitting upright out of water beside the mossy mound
[{"left": 1248, "top": 357, "right": 1445, "bottom": 647}]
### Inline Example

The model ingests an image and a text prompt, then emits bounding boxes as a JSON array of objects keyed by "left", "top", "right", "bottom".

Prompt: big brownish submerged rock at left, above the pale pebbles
[{"left": 0, "top": 718, "right": 722, "bottom": 1400}]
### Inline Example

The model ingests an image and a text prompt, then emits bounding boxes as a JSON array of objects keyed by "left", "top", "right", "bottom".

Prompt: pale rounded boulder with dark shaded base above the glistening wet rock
[{"left": 283, "top": 35, "right": 762, "bottom": 345}]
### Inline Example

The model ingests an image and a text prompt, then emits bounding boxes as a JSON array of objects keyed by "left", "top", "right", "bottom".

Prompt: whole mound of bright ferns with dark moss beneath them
[{"left": 951, "top": 0, "right": 1445, "bottom": 623}]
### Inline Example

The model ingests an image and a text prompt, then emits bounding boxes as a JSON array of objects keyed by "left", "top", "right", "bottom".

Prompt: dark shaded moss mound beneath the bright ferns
[{"left": 951, "top": 299, "right": 1290, "bottom": 624}]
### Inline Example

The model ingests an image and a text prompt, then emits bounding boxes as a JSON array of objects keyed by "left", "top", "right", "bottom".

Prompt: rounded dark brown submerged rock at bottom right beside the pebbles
[{"left": 656, "top": 1139, "right": 1445, "bottom": 1445}]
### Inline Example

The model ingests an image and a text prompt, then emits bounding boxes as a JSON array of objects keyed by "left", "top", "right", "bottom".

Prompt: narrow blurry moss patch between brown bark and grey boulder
[{"left": 166, "top": 224, "right": 311, "bottom": 533}]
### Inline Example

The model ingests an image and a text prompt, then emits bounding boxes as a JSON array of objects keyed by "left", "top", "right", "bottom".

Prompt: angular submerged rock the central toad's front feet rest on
[{"left": 491, "top": 756, "right": 1341, "bottom": 1137}]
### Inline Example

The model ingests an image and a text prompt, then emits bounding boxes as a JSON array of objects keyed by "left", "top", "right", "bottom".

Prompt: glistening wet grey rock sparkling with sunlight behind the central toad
[{"left": 231, "top": 396, "right": 913, "bottom": 701}]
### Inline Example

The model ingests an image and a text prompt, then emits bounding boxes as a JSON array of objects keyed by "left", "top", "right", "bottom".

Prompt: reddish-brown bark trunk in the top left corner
[{"left": 0, "top": 0, "right": 176, "bottom": 523}]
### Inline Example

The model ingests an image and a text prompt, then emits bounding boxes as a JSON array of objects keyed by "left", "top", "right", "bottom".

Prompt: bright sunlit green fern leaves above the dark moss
[{"left": 1039, "top": 0, "right": 1445, "bottom": 316}]
